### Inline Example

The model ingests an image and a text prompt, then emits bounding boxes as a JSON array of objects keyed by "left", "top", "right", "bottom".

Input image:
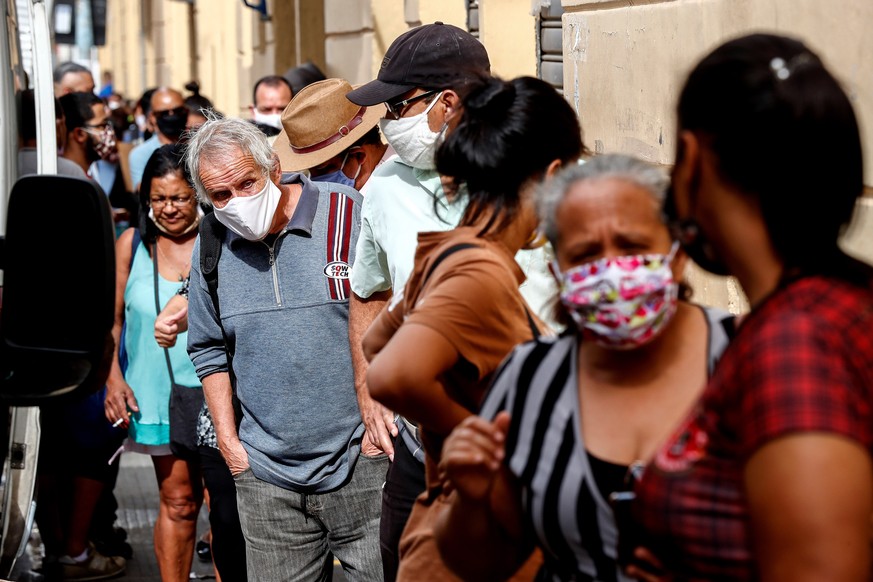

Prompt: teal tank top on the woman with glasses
[{"left": 124, "top": 244, "right": 201, "bottom": 445}]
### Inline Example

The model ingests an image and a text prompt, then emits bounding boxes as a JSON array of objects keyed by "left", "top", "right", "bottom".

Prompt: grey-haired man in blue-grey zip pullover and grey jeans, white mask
[{"left": 187, "top": 119, "right": 387, "bottom": 581}]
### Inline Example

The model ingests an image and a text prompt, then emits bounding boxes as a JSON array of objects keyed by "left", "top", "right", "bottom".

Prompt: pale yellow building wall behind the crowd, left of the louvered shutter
[{"left": 98, "top": 0, "right": 536, "bottom": 110}]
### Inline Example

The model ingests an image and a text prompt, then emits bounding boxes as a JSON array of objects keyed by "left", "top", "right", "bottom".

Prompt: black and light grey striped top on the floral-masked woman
[{"left": 481, "top": 308, "right": 734, "bottom": 582}]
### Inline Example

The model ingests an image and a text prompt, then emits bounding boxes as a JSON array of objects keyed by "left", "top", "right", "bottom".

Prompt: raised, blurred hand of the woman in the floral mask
[{"left": 439, "top": 412, "right": 509, "bottom": 501}]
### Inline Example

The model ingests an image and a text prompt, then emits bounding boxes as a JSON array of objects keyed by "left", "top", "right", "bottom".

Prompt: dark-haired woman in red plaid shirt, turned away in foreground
[{"left": 635, "top": 34, "right": 873, "bottom": 582}]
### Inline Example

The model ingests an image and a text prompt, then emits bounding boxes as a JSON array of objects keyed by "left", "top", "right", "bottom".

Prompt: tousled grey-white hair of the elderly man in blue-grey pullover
[{"left": 185, "top": 110, "right": 274, "bottom": 206}]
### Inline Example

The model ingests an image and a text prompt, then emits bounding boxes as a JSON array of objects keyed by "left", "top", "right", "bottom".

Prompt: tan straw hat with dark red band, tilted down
[{"left": 273, "top": 79, "right": 385, "bottom": 172}]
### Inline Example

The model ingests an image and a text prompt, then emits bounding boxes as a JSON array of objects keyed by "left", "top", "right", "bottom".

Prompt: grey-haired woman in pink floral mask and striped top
[{"left": 437, "top": 155, "right": 733, "bottom": 580}]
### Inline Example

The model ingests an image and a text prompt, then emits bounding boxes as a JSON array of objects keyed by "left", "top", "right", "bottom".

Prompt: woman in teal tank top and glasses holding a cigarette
[{"left": 106, "top": 145, "right": 203, "bottom": 582}]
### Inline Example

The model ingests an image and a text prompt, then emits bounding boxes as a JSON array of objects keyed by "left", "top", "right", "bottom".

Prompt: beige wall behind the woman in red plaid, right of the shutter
[{"left": 563, "top": 0, "right": 873, "bottom": 311}]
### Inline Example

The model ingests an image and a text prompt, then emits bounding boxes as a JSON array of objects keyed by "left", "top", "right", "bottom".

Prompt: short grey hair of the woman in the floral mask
[{"left": 536, "top": 154, "right": 670, "bottom": 246}]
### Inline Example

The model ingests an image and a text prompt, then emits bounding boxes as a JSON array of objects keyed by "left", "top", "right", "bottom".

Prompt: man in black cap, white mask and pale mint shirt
[{"left": 347, "top": 22, "right": 490, "bottom": 581}]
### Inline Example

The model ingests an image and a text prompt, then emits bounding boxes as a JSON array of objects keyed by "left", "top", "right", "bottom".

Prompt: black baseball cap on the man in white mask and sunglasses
[{"left": 346, "top": 22, "right": 491, "bottom": 107}]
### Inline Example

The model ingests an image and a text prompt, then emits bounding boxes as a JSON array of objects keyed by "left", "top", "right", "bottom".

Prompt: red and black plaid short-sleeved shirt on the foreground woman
[{"left": 635, "top": 277, "right": 873, "bottom": 580}]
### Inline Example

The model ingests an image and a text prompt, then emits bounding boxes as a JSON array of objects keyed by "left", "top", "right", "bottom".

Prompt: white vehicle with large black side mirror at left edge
[{"left": 0, "top": 0, "right": 115, "bottom": 578}]
